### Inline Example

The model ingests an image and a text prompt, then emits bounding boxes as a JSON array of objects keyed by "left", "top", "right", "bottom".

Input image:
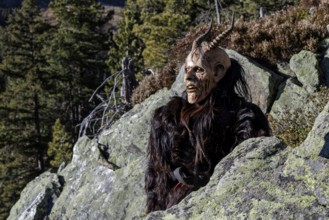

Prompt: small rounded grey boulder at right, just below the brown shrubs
[{"left": 289, "top": 50, "right": 322, "bottom": 88}]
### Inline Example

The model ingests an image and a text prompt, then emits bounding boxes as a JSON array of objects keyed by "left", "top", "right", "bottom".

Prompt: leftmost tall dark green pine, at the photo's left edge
[{"left": 0, "top": 0, "right": 49, "bottom": 166}]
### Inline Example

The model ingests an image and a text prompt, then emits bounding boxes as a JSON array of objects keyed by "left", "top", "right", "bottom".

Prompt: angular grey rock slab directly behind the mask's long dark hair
[{"left": 226, "top": 50, "right": 283, "bottom": 113}]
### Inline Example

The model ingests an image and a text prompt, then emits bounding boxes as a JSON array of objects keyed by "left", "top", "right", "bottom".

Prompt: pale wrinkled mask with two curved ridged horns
[{"left": 184, "top": 15, "right": 234, "bottom": 104}]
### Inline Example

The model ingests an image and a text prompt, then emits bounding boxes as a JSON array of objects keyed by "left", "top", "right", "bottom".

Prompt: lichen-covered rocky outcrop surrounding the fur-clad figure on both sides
[{"left": 9, "top": 51, "right": 329, "bottom": 219}]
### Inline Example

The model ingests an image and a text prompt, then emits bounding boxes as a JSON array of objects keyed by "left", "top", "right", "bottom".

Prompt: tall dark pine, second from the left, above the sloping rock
[{"left": 45, "top": 0, "right": 112, "bottom": 138}]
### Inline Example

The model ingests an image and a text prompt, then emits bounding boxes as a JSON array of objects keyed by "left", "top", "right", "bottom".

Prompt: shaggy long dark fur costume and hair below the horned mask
[{"left": 145, "top": 59, "right": 270, "bottom": 212}]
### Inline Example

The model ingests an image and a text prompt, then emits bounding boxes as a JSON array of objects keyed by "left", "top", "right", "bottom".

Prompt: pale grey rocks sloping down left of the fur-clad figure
[{"left": 10, "top": 89, "right": 170, "bottom": 220}]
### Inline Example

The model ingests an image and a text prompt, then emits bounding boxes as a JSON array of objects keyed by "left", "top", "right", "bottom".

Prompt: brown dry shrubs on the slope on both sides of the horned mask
[{"left": 133, "top": 0, "right": 329, "bottom": 104}]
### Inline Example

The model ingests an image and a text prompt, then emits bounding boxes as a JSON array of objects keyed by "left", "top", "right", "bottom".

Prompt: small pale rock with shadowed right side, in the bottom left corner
[{"left": 8, "top": 171, "right": 62, "bottom": 220}]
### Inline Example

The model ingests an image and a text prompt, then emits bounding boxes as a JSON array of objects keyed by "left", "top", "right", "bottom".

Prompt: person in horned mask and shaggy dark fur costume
[{"left": 145, "top": 19, "right": 270, "bottom": 212}]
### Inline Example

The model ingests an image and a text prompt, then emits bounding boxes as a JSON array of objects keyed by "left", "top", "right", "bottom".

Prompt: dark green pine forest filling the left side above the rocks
[{"left": 0, "top": 0, "right": 111, "bottom": 219}]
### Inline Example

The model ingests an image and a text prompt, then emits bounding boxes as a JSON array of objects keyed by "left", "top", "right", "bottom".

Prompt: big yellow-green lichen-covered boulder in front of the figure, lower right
[{"left": 146, "top": 137, "right": 329, "bottom": 220}]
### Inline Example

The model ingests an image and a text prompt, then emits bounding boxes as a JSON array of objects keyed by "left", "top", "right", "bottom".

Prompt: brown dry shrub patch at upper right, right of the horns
[{"left": 229, "top": 0, "right": 329, "bottom": 66}]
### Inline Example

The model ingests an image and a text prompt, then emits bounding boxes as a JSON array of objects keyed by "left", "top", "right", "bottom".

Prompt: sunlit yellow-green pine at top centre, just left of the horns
[{"left": 128, "top": 0, "right": 215, "bottom": 70}]
